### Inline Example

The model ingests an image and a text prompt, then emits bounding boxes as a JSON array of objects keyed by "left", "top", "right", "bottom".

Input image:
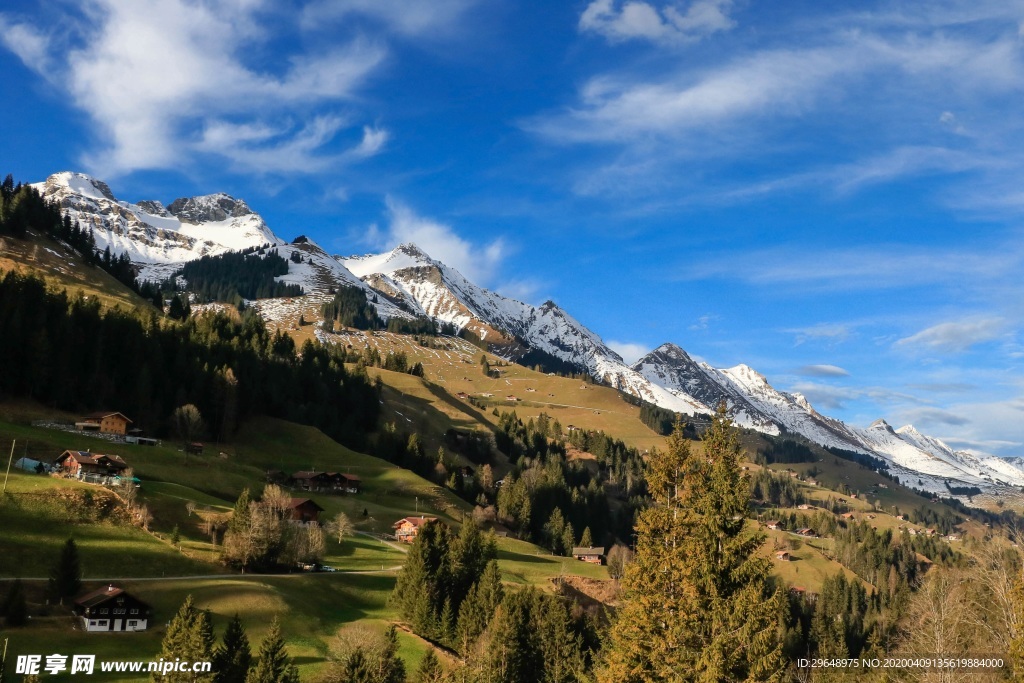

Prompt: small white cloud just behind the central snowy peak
[{"left": 378, "top": 197, "right": 508, "bottom": 285}]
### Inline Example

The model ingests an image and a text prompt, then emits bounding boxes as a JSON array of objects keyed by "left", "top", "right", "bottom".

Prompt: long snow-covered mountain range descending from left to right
[{"left": 36, "top": 172, "right": 1024, "bottom": 495}]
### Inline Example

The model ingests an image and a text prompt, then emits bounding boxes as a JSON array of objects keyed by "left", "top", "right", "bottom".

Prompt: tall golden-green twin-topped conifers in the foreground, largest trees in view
[{"left": 598, "top": 408, "right": 783, "bottom": 683}]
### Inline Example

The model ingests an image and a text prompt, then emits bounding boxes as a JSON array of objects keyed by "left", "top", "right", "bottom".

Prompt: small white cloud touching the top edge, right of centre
[{"left": 580, "top": 0, "right": 734, "bottom": 43}]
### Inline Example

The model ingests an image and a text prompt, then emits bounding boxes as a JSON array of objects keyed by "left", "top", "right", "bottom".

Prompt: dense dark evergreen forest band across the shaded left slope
[{"left": 0, "top": 272, "right": 379, "bottom": 447}]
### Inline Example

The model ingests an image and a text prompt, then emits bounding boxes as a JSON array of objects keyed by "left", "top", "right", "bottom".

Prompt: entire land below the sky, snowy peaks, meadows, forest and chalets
[{"left": 0, "top": 172, "right": 1024, "bottom": 683}]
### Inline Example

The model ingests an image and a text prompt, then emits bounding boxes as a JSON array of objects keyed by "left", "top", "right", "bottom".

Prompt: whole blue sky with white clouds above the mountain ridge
[{"left": 0, "top": 0, "right": 1024, "bottom": 455}]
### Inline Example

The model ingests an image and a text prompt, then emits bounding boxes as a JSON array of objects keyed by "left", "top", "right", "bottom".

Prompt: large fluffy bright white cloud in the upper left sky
[{"left": 0, "top": 0, "right": 386, "bottom": 175}]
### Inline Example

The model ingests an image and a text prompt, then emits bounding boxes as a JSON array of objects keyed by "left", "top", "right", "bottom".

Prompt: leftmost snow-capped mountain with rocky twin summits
[{"left": 34, "top": 171, "right": 283, "bottom": 280}]
